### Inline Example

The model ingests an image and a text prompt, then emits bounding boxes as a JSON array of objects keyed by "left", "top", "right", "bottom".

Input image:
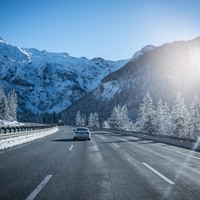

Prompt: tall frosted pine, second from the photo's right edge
[{"left": 172, "top": 93, "right": 188, "bottom": 137}]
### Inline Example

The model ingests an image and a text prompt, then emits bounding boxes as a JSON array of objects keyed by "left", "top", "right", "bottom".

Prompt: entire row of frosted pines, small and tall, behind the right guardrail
[{"left": 103, "top": 92, "right": 200, "bottom": 139}]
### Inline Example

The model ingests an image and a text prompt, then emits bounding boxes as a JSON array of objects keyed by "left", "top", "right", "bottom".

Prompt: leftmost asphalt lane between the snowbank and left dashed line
[{"left": 0, "top": 126, "right": 73, "bottom": 200}]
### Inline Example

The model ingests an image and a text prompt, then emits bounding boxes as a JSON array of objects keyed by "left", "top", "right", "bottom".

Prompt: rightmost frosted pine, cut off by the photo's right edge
[{"left": 189, "top": 95, "right": 200, "bottom": 139}]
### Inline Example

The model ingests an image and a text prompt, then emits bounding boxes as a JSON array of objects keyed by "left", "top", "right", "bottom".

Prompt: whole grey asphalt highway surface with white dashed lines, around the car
[{"left": 0, "top": 126, "right": 200, "bottom": 200}]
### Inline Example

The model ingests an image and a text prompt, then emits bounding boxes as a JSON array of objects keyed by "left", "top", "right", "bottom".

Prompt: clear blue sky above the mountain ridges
[{"left": 0, "top": 0, "right": 200, "bottom": 60}]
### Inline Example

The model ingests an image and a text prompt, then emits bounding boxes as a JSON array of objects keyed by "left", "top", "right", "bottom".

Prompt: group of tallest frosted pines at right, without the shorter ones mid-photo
[{"left": 135, "top": 92, "right": 200, "bottom": 139}]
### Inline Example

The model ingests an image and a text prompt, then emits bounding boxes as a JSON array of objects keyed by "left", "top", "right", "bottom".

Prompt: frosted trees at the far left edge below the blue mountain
[{"left": 0, "top": 89, "right": 18, "bottom": 121}]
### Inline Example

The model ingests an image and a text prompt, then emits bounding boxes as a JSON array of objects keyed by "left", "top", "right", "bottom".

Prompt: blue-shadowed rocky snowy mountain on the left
[{"left": 0, "top": 38, "right": 129, "bottom": 119}]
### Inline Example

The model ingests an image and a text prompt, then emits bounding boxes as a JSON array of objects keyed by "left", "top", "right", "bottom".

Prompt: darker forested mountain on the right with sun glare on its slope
[{"left": 62, "top": 37, "right": 200, "bottom": 123}]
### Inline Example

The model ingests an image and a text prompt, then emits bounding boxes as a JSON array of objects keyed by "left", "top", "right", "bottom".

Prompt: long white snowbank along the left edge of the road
[{"left": 0, "top": 127, "right": 58, "bottom": 150}]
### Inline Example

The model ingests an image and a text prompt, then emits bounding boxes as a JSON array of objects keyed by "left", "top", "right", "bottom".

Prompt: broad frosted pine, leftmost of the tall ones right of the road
[{"left": 136, "top": 92, "right": 155, "bottom": 133}]
